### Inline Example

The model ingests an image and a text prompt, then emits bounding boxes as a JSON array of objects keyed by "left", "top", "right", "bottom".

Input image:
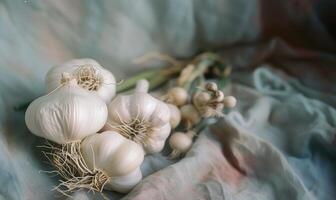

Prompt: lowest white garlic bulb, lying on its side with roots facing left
[{"left": 81, "top": 131, "right": 144, "bottom": 192}]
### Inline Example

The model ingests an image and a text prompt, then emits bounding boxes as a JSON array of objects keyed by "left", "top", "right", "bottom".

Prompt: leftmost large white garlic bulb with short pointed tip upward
[{"left": 25, "top": 74, "right": 107, "bottom": 144}]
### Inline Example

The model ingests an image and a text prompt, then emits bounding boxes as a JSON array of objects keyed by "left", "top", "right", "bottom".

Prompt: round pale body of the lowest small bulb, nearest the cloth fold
[{"left": 169, "top": 132, "right": 192, "bottom": 153}]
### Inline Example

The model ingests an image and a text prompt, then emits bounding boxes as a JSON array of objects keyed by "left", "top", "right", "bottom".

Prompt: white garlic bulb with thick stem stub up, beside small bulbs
[{"left": 107, "top": 80, "right": 171, "bottom": 153}]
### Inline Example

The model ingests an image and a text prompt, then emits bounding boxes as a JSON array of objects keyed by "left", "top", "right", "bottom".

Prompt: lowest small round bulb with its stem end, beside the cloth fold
[{"left": 169, "top": 131, "right": 196, "bottom": 158}]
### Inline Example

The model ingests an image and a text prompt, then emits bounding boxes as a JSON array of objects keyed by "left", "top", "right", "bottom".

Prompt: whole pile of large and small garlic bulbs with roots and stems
[{"left": 21, "top": 54, "right": 236, "bottom": 195}]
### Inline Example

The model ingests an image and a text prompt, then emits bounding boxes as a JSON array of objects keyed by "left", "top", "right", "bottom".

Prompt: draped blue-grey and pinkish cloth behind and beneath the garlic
[{"left": 0, "top": 0, "right": 336, "bottom": 200}]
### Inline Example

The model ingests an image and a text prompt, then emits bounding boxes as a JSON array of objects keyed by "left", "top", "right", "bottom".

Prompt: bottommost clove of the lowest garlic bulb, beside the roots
[{"left": 105, "top": 167, "right": 142, "bottom": 193}]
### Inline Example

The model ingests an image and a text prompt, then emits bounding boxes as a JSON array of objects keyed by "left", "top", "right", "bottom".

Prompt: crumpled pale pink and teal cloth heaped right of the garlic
[{"left": 118, "top": 66, "right": 336, "bottom": 200}]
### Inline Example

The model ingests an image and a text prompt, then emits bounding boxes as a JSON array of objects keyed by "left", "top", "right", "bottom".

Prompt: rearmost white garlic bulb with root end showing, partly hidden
[{"left": 45, "top": 58, "right": 116, "bottom": 103}]
